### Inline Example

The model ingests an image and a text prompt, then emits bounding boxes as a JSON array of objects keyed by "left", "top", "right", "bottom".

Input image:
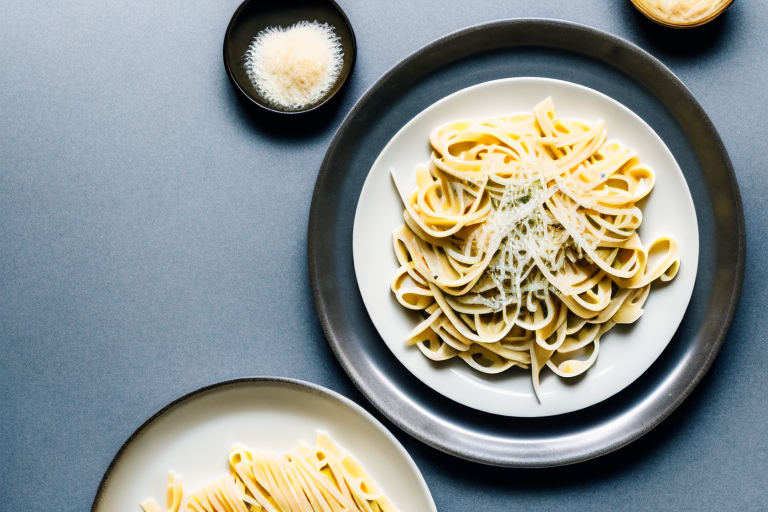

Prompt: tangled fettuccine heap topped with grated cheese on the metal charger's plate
[{"left": 391, "top": 98, "right": 680, "bottom": 400}]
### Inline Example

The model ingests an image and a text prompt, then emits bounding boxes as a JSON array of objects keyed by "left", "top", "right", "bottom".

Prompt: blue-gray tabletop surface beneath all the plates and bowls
[{"left": 0, "top": 0, "right": 768, "bottom": 511}]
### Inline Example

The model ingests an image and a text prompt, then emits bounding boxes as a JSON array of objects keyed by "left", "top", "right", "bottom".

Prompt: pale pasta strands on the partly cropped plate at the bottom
[{"left": 141, "top": 432, "right": 397, "bottom": 512}]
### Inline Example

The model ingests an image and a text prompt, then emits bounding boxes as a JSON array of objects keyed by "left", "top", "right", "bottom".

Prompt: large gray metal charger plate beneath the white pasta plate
[{"left": 308, "top": 19, "right": 746, "bottom": 467}]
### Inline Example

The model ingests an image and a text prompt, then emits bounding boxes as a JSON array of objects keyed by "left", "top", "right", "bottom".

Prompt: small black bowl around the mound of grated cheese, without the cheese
[{"left": 224, "top": 0, "right": 357, "bottom": 114}]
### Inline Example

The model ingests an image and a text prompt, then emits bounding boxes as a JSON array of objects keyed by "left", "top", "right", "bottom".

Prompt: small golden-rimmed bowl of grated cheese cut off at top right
[{"left": 631, "top": 0, "right": 733, "bottom": 28}]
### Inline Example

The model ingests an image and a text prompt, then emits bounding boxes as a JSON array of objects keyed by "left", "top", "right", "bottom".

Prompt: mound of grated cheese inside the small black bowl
[{"left": 245, "top": 21, "right": 344, "bottom": 109}]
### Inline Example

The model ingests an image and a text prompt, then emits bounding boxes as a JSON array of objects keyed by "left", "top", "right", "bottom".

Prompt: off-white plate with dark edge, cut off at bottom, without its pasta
[{"left": 91, "top": 378, "right": 437, "bottom": 512}]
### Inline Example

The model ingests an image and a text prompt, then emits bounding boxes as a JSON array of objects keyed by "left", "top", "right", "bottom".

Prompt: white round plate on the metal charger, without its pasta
[{"left": 352, "top": 78, "right": 699, "bottom": 416}]
